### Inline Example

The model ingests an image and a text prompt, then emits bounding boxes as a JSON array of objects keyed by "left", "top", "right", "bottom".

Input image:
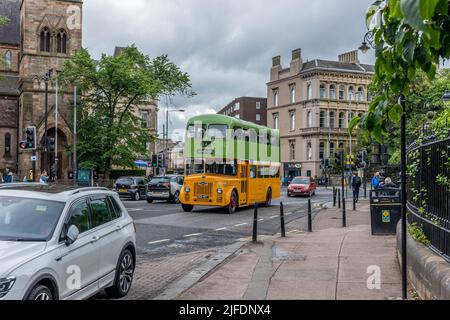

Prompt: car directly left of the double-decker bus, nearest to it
[{"left": 147, "top": 175, "right": 184, "bottom": 204}]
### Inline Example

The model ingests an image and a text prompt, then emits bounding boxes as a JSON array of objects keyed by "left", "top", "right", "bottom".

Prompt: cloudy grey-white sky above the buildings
[{"left": 83, "top": 0, "right": 374, "bottom": 140}]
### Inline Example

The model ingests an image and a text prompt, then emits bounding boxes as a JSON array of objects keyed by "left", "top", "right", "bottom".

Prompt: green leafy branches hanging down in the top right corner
[{"left": 350, "top": 0, "right": 450, "bottom": 141}]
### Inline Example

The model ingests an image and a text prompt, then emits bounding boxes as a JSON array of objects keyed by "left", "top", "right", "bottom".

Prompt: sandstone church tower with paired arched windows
[{"left": 18, "top": 0, "right": 83, "bottom": 180}]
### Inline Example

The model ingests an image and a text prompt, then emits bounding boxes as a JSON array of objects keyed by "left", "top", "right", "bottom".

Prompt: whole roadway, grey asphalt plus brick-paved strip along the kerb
[{"left": 103, "top": 189, "right": 331, "bottom": 299}]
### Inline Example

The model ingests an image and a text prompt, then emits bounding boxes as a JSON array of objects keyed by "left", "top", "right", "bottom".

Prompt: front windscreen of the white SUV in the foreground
[{"left": 0, "top": 196, "right": 65, "bottom": 241}]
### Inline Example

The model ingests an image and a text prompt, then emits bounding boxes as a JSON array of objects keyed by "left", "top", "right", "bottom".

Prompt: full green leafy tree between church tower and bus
[{"left": 60, "top": 46, "right": 194, "bottom": 178}]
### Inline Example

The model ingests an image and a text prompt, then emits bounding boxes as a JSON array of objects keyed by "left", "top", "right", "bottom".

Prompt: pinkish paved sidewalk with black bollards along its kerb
[{"left": 178, "top": 201, "right": 401, "bottom": 300}]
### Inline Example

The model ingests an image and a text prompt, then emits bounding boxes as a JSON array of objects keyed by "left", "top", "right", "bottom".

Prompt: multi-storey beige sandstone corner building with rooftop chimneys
[{"left": 267, "top": 49, "right": 374, "bottom": 177}]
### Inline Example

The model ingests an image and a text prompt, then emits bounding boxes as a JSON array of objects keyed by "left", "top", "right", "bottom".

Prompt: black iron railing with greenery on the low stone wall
[{"left": 407, "top": 136, "right": 450, "bottom": 262}]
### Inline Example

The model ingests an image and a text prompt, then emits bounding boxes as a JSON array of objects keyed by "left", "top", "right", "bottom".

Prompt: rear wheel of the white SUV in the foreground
[{"left": 105, "top": 249, "right": 134, "bottom": 298}]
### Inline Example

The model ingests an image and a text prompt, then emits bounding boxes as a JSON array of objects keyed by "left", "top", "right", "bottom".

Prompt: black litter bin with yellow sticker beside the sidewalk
[{"left": 370, "top": 188, "right": 402, "bottom": 235}]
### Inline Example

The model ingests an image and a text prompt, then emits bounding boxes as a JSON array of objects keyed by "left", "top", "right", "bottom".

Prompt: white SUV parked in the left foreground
[{"left": 0, "top": 184, "right": 136, "bottom": 300}]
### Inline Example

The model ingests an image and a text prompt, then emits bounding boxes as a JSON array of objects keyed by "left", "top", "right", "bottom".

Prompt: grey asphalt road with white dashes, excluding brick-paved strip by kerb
[{"left": 123, "top": 188, "right": 332, "bottom": 259}]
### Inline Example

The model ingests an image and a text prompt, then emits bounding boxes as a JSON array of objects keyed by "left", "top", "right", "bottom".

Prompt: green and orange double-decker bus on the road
[{"left": 180, "top": 115, "right": 281, "bottom": 214}]
